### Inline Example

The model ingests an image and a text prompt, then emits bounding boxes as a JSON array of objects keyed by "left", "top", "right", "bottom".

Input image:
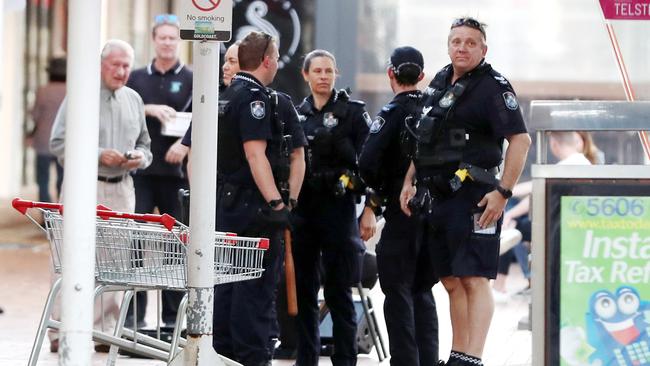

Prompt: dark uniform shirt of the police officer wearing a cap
[{"left": 359, "top": 90, "right": 422, "bottom": 204}]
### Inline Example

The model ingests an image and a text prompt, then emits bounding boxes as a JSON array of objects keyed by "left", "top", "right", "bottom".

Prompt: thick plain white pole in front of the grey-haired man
[{"left": 59, "top": 0, "right": 101, "bottom": 366}]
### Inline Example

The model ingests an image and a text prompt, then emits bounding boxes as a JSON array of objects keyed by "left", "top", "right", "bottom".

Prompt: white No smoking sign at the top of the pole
[{"left": 178, "top": 0, "right": 232, "bottom": 42}]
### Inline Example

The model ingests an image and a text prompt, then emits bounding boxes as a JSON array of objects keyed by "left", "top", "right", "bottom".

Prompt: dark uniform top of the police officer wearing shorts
[{"left": 425, "top": 61, "right": 527, "bottom": 169}]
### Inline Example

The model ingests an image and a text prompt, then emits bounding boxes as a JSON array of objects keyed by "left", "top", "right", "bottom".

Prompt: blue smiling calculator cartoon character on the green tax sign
[{"left": 586, "top": 286, "right": 650, "bottom": 366}]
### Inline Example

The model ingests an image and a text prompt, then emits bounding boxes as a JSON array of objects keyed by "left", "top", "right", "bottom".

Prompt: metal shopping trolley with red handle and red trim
[{"left": 12, "top": 198, "right": 269, "bottom": 365}]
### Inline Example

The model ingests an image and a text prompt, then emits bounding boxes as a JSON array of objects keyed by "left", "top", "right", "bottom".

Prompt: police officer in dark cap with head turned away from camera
[{"left": 359, "top": 47, "right": 438, "bottom": 366}]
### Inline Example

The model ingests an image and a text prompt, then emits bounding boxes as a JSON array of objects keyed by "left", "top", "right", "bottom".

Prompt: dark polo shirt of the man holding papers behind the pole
[{"left": 127, "top": 61, "right": 192, "bottom": 177}]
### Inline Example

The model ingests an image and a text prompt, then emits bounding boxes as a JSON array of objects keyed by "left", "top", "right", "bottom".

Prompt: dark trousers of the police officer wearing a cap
[{"left": 377, "top": 213, "right": 438, "bottom": 366}]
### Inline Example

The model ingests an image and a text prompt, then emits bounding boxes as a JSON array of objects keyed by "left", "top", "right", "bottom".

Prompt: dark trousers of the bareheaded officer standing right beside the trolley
[{"left": 213, "top": 188, "right": 283, "bottom": 366}]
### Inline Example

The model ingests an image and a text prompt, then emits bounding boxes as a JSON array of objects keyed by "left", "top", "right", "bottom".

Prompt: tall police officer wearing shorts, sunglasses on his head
[{"left": 400, "top": 18, "right": 530, "bottom": 365}]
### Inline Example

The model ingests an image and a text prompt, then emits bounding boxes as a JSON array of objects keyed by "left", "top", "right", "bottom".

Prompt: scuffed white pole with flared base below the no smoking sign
[{"left": 171, "top": 41, "right": 223, "bottom": 366}]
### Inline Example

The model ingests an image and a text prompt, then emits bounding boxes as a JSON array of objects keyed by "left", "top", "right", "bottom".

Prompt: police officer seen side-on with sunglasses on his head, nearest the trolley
[{"left": 214, "top": 32, "right": 306, "bottom": 366}]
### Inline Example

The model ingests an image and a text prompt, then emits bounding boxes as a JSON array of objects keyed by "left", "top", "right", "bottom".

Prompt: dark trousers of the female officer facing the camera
[{"left": 293, "top": 197, "right": 364, "bottom": 366}]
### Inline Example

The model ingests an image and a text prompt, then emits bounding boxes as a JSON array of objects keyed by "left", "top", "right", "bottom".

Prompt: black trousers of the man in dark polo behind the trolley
[{"left": 127, "top": 175, "right": 188, "bottom": 326}]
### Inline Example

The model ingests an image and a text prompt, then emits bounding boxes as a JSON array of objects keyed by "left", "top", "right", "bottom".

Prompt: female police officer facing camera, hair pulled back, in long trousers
[{"left": 293, "top": 50, "right": 375, "bottom": 366}]
